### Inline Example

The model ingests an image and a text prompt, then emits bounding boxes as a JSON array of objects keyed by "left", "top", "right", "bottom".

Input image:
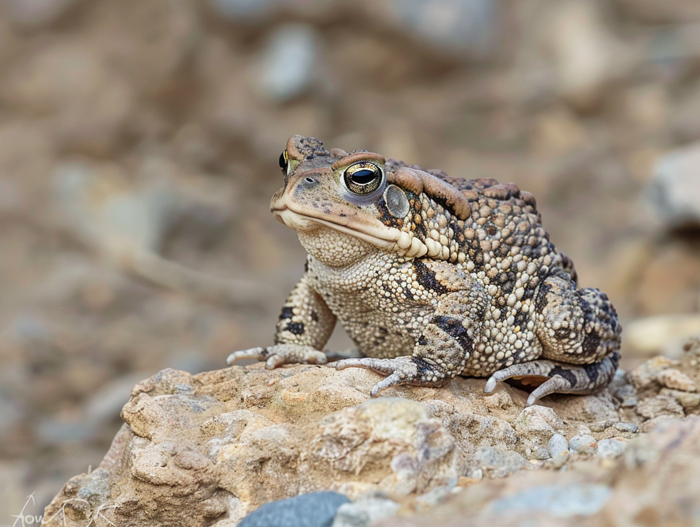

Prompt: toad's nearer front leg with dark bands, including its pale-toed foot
[{"left": 336, "top": 286, "right": 488, "bottom": 397}]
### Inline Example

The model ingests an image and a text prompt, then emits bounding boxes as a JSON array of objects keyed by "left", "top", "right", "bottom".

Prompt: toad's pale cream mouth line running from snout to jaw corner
[{"left": 271, "top": 203, "right": 430, "bottom": 258}]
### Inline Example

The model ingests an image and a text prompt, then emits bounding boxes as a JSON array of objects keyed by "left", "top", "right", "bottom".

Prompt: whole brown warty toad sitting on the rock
[{"left": 229, "top": 136, "right": 621, "bottom": 404}]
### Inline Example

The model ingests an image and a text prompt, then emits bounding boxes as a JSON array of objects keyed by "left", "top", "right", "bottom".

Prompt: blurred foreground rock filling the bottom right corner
[{"left": 382, "top": 417, "right": 700, "bottom": 527}]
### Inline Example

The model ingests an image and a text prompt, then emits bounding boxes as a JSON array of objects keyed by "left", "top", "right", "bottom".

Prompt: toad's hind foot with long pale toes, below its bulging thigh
[{"left": 484, "top": 352, "right": 620, "bottom": 406}]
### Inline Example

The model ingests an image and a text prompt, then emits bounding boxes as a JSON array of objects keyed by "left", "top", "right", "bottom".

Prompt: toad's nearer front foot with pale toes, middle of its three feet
[{"left": 335, "top": 357, "right": 449, "bottom": 397}]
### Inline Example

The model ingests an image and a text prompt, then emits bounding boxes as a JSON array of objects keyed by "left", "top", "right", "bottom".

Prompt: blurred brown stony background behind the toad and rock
[{"left": 0, "top": 0, "right": 700, "bottom": 525}]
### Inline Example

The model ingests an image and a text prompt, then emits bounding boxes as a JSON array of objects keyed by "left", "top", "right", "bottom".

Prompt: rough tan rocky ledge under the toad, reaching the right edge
[{"left": 44, "top": 341, "right": 700, "bottom": 526}]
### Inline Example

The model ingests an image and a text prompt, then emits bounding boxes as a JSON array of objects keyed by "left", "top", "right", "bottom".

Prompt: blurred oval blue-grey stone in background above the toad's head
[{"left": 257, "top": 24, "right": 320, "bottom": 103}]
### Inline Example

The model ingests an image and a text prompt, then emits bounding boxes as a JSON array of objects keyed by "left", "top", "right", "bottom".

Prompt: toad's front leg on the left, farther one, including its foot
[{"left": 226, "top": 275, "right": 336, "bottom": 369}]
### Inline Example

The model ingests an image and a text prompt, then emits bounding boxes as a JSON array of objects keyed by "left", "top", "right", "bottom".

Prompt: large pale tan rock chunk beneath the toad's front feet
[{"left": 42, "top": 366, "right": 459, "bottom": 525}]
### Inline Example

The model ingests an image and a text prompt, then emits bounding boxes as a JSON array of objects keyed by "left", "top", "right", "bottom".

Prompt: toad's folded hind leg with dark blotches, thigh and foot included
[{"left": 485, "top": 269, "right": 622, "bottom": 405}]
